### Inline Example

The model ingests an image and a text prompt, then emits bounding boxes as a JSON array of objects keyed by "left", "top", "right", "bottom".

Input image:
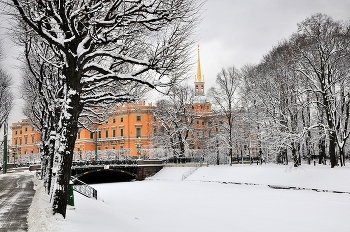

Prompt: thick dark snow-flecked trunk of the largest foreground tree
[{"left": 51, "top": 56, "right": 83, "bottom": 218}]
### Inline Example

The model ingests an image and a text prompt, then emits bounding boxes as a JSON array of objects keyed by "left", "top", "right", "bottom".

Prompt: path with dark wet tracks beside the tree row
[{"left": 0, "top": 172, "right": 35, "bottom": 232}]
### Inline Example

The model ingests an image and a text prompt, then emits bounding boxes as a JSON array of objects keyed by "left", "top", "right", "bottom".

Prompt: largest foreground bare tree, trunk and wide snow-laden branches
[{"left": 8, "top": 0, "right": 199, "bottom": 217}]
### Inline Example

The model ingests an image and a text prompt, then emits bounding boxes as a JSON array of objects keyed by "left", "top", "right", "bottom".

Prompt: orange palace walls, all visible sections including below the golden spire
[{"left": 10, "top": 102, "right": 254, "bottom": 162}]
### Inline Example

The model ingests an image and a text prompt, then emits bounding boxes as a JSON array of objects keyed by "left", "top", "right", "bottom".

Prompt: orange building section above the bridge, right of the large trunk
[{"left": 75, "top": 101, "right": 153, "bottom": 159}]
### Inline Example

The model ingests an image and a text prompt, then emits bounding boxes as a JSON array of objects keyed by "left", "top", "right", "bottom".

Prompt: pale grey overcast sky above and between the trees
[{"left": 0, "top": 0, "right": 350, "bottom": 125}]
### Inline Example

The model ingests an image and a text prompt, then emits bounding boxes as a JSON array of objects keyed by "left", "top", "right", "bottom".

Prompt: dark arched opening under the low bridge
[{"left": 74, "top": 169, "right": 136, "bottom": 184}]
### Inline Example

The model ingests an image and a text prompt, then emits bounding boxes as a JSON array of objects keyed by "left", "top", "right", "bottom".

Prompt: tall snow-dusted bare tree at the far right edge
[{"left": 291, "top": 14, "right": 350, "bottom": 168}]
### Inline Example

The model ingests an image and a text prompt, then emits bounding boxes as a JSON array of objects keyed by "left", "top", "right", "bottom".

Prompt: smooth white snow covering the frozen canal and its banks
[{"left": 28, "top": 165, "right": 350, "bottom": 232}]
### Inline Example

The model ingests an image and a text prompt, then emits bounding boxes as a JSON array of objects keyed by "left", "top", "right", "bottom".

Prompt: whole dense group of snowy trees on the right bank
[{"left": 245, "top": 14, "right": 350, "bottom": 167}]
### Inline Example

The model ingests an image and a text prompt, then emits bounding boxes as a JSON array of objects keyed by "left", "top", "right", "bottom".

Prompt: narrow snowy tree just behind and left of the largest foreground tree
[{"left": 20, "top": 33, "right": 62, "bottom": 196}]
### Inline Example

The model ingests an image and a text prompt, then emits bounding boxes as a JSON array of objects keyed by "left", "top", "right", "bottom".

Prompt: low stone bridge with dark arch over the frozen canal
[{"left": 72, "top": 160, "right": 163, "bottom": 184}]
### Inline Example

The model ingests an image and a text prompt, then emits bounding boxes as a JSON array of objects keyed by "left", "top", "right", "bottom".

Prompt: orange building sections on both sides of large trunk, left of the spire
[{"left": 9, "top": 102, "right": 153, "bottom": 162}]
